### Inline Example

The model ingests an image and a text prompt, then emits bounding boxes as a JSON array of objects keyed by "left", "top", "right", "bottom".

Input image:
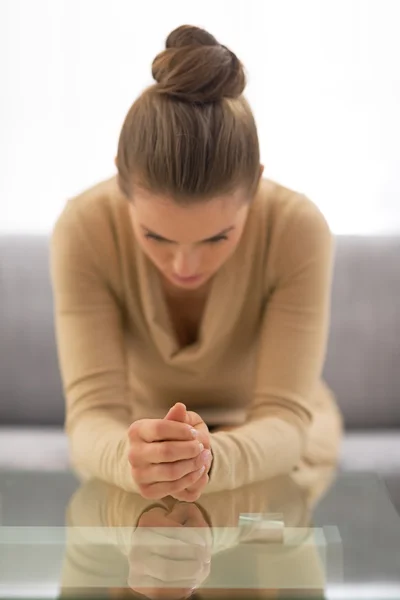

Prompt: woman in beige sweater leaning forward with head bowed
[{"left": 51, "top": 26, "right": 341, "bottom": 501}]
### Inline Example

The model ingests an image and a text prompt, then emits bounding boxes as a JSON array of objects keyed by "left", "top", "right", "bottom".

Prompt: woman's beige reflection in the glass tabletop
[{"left": 61, "top": 470, "right": 333, "bottom": 599}]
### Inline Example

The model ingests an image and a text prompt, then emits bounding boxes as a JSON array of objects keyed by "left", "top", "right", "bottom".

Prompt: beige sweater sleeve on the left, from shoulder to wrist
[{"left": 50, "top": 201, "right": 137, "bottom": 491}]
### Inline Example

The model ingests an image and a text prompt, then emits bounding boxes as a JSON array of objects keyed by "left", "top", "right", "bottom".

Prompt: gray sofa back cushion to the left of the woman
[{"left": 0, "top": 235, "right": 64, "bottom": 426}]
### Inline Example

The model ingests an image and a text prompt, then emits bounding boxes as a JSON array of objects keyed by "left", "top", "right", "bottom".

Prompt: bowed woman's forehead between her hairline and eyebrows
[{"left": 130, "top": 193, "right": 247, "bottom": 242}]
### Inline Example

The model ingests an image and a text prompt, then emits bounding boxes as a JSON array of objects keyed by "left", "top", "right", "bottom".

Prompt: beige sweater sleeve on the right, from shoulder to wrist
[{"left": 207, "top": 197, "right": 334, "bottom": 493}]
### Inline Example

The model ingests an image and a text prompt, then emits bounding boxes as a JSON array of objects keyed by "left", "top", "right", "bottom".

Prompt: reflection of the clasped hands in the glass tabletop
[{"left": 128, "top": 502, "right": 212, "bottom": 600}]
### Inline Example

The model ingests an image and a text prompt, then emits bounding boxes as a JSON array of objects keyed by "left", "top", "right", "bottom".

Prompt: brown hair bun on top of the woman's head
[{"left": 152, "top": 25, "right": 246, "bottom": 102}]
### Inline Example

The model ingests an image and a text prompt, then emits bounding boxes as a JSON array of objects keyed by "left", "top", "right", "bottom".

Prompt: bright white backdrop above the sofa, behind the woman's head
[{"left": 0, "top": 0, "right": 400, "bottom": 234}]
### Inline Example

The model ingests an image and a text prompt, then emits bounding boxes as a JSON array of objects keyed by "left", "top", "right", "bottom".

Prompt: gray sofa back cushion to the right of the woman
[{"left": 324, "top": 236, "right": 400, "bottom": 429}]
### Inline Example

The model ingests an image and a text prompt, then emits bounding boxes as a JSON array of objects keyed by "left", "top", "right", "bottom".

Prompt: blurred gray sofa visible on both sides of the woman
[{"left": 0, "top": 235, "right": 400, "bottom": 502}]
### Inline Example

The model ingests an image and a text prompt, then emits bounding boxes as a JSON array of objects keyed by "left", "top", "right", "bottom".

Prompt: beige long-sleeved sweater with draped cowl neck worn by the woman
[{"left": 51, "top": 177, "right": 341, "bottom": 492}]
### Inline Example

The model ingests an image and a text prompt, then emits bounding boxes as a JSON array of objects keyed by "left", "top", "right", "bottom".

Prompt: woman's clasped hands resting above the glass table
[{"left": 128, "top": 402, "right": 212, "bottom": 502}]
